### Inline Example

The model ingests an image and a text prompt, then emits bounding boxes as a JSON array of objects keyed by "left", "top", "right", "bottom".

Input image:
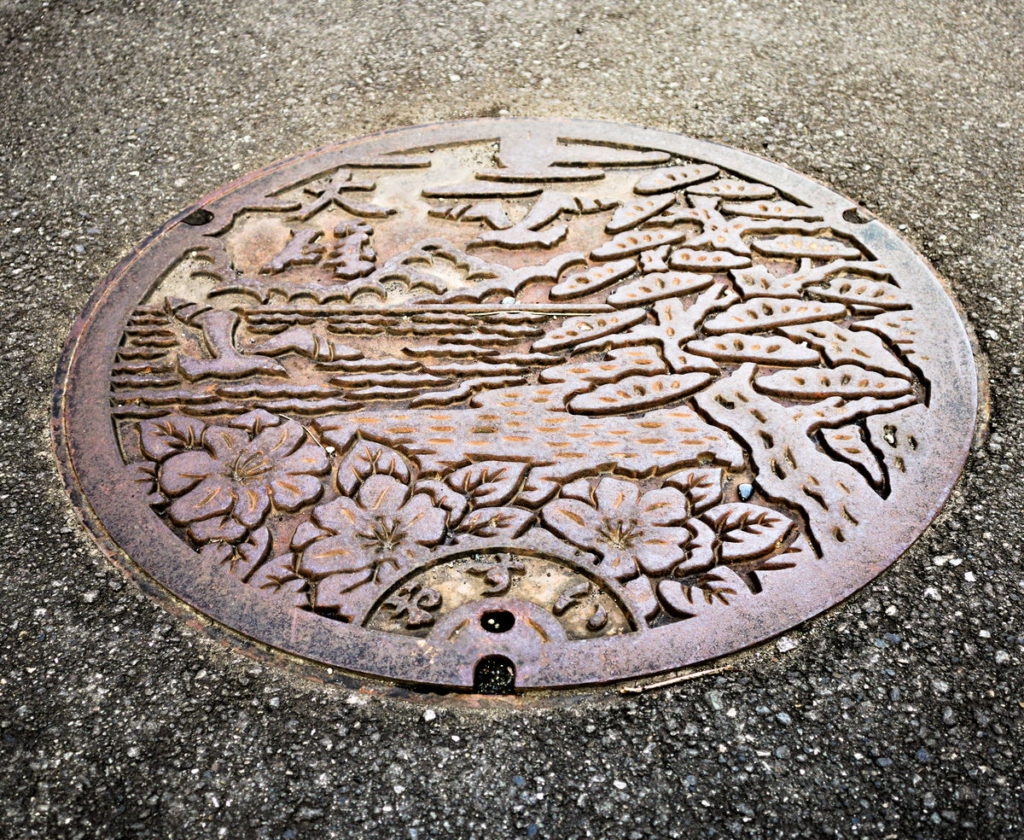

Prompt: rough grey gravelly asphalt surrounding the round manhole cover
[{"left": 0, "top": 0, "right": 1024, "bottom": 840}]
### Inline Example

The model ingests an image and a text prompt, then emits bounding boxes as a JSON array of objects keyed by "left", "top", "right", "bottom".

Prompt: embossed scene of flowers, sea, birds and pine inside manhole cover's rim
[{"left": 113, "top": 129, "right": 925, "bottom": 635}]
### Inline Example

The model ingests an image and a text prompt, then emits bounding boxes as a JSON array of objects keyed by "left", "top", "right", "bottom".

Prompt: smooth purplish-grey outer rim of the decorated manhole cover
[{"left": 52, "top": 120, "right": 978, "bottom": 687}]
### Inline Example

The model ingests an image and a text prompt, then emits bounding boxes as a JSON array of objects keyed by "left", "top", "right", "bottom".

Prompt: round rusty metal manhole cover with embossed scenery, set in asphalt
[{"left": 55, "top": 120, "right": 976, "bottom": 691}]
